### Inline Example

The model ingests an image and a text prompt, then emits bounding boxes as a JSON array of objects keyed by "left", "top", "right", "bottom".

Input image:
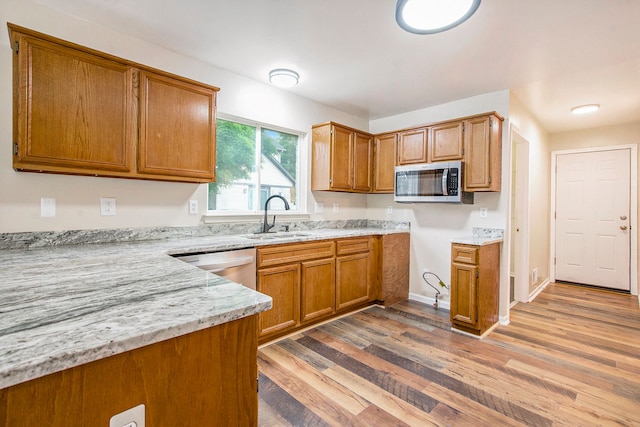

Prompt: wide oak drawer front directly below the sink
[{"left": 258, "top": 240, "right": 335, "bottom": 268}]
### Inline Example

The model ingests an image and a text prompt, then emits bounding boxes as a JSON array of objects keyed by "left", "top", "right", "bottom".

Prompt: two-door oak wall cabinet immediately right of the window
[{"left": 311, "top": 122, "right": 373, "bottom": 193}]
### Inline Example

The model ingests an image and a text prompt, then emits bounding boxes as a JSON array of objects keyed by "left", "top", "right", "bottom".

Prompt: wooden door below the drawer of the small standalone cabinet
[{"left": 450, "top": 263, "right": 478, "bottom": 328}]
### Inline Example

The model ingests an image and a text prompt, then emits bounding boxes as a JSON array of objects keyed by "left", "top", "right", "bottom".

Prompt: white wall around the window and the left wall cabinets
[{"left": 0, "top": 0, "right": 368, "bottom": 232}]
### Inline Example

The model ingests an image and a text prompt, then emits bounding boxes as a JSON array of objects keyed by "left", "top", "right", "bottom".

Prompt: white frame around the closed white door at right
[{"left": 549, "top": 144, "right": 640, "bottom": 300}]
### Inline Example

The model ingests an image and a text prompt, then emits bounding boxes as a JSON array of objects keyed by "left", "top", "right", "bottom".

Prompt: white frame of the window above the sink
[{"left": 205, "top": 113, "right": 309, "bottom": 217}]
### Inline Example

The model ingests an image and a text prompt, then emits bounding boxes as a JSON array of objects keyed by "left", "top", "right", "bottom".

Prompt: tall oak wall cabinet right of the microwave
[{"left": 464, "top": 114, "right": 502, "bottom": 191}]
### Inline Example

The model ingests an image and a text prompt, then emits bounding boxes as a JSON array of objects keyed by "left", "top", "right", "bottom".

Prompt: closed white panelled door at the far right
[{"left": 555, "top": 149, "right": 631, "bottom": 291}]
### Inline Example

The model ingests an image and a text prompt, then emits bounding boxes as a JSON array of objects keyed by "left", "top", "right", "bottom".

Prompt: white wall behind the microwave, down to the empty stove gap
[{"left": 367, "top": 90, "right": 509, "bottom": 316}]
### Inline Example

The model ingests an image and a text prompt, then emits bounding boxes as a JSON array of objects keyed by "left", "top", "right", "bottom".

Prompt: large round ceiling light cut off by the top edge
[{"left": 396, "top": 0, "right": 480, "bottom": 34}]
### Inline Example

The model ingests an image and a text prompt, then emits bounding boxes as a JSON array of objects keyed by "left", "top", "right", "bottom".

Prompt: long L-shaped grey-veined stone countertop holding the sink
[{"left": 0, "top": 220, "right": 408, "bottom": 388}]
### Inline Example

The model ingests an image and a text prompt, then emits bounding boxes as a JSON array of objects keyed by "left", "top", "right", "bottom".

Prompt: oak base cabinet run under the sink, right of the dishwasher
[{"left": 256, "top": 236, "right": 379, "bottom": 343}]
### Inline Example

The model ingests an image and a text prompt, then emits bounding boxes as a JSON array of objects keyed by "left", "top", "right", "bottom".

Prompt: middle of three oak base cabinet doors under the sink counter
[{"left": 300, "top": 258, "right": 336, "bottom": 323}]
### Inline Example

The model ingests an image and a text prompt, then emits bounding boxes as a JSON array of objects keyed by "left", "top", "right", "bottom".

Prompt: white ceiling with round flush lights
[{"left": 36, "top": 0, "right": 640, "bottom": 133}]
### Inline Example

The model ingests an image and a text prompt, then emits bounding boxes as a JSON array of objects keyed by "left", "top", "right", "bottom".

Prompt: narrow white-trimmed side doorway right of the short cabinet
[{"left": 509, "top": 125, "right": 530, "bottom": 302}]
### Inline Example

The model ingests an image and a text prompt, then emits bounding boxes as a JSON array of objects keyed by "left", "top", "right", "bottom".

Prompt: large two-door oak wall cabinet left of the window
[{"left": 8, "top": 24, "right": 218, "bottom": 182}]
